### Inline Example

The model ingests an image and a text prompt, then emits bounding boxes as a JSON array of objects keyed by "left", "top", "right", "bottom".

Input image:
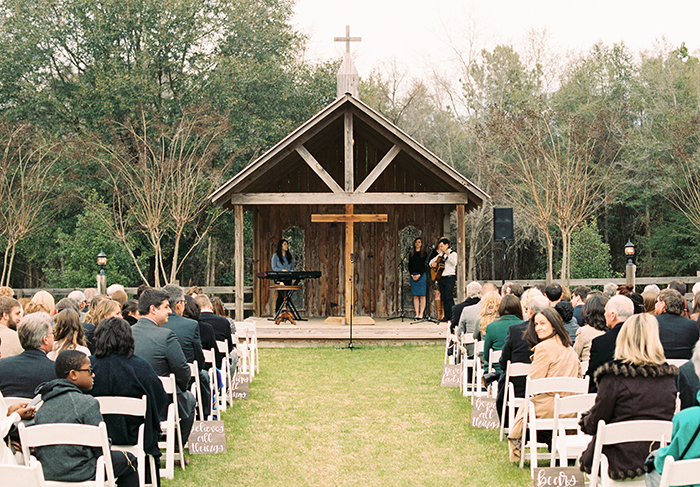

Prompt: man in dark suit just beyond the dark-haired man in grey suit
[{"left": 162, "top": 284, "right": 211, "bottom": 416}]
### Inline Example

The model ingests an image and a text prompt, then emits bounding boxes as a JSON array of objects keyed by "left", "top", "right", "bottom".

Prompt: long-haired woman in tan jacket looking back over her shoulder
[{"left": 508, "top": 306, "right": 581, "bottom": 462}]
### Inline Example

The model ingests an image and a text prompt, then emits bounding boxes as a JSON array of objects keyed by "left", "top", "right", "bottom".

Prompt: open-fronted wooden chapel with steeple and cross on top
[{"left": 210, "top": 32, "right": 489, "bottom": 319}]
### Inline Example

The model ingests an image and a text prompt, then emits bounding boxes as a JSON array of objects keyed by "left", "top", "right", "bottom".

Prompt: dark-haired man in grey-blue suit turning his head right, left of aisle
[{"left": 131, "top": 289, "right": 196, "bottom": 444}]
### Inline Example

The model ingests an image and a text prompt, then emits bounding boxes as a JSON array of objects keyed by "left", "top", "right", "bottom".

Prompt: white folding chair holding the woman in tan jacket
[{"left": 520, "top": 376, "right": 588, "bottom": 476}]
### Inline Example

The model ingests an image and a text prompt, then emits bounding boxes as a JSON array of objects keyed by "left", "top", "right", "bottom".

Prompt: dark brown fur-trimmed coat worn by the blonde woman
[{"left": 580, "top": 360, "right": 678, "bottom": 480}]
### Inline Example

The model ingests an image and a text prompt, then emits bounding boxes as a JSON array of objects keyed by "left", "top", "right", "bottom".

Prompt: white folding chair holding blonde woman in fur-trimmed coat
[{"left": 590, "top": 419, "right": 673, "bottom": 487}]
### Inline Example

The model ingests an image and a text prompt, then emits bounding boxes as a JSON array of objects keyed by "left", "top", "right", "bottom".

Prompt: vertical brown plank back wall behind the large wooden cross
[{"left": 252, "top": 205, "right": 443, "bottom": 317}]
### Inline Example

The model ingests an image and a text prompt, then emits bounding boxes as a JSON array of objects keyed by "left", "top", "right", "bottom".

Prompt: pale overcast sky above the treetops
[{"left": 292, "top": 0, "right": 700, "bottom": 77}]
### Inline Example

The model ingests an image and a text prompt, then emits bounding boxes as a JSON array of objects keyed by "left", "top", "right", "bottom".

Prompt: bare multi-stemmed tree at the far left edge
[{"left": 0, "top": 124, "right": 60, "bottom": 285}]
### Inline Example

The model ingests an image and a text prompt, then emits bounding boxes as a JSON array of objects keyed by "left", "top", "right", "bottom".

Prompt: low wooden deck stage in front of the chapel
[{"left": 245, "top": 316, "right": 448, "bottom": 348}]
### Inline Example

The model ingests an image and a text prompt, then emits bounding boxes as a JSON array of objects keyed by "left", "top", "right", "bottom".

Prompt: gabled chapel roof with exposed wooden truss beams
[{"left": 209, "top": 94, "right": 489, "bottom": 207}]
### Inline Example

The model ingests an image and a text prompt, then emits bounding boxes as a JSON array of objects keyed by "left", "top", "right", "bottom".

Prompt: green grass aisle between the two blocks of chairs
[{"left": 163, "top": 346, "right": 531, "bottom": 487}]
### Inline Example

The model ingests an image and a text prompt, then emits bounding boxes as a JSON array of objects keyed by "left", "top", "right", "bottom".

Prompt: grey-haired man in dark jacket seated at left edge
[{"left": 0, "top": 313, "right": 56, "bottom": 398}]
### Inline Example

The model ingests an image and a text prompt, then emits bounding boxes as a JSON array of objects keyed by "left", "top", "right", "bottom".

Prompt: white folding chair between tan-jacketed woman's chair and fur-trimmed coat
[{"left": 551, "top": 394, "right": 596, "bottom": 467}]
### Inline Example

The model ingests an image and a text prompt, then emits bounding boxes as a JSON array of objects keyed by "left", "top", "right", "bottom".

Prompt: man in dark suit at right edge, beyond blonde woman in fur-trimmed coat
[{"left": 655, "top": 289, "right": 700, "bottom": 359}]
